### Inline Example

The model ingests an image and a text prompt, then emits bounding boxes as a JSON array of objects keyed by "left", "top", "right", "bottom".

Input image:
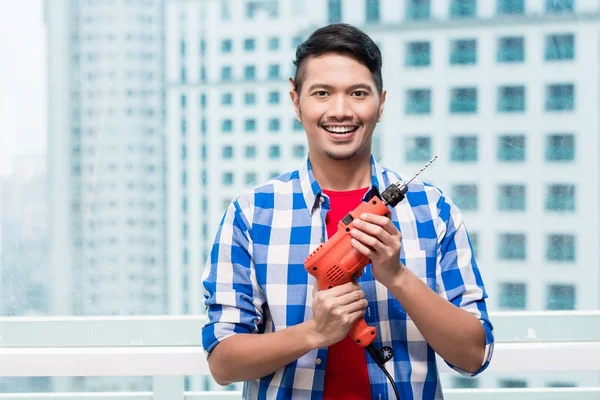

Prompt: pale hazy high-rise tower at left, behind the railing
[{"left": 46, "top": 0, "right": 169, "bottom": 390}]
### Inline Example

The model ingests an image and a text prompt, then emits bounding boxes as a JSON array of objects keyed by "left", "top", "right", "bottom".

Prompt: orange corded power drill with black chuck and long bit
[{"left": 304, "top": 156, "right": 437, "bottom": 396}]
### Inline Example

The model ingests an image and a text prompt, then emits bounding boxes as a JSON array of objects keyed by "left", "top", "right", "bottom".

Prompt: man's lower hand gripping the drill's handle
[{"left": 312, "top": 282, "right": 368, "bottom": 347}]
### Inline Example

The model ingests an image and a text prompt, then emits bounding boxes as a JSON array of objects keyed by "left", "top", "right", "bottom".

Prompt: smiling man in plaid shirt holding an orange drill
[{"left": 202, "top": 24, "right": 493, "bottom": 400}]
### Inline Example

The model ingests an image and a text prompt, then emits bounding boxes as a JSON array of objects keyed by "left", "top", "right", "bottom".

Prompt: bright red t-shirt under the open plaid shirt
[{"left": 323, "top": 188, "right": 371, "bottom": 400}]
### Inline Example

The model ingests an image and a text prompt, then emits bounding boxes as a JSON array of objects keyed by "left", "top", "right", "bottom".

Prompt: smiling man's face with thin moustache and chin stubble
[{"left": 290, "top": 53, "right": 385, "bottom": 160}]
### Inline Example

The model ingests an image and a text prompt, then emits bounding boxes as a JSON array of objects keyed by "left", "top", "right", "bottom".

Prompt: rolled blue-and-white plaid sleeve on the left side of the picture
[{"left": 202, "top": 200, "right": 265, "bottom": 354}]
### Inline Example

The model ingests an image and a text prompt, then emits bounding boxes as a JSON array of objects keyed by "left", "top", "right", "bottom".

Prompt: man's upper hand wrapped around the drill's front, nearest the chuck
[{"left": 350, "top": 214, "right": 404, "bottom": 288}]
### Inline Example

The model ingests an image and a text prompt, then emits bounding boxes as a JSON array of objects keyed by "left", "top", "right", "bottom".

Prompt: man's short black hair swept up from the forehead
[{"left": 294, "top": 24, "right": 383, "bottom": 94}]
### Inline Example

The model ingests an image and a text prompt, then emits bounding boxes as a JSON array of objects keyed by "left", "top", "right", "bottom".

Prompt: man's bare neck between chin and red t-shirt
[{"left": 309, "top": 152, "right": 371, "bottom": 191}]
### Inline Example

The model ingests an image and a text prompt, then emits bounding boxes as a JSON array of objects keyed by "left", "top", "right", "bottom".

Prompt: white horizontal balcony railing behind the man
[{"left": 0, "top": 311, "right": 600, "bottom": 400}]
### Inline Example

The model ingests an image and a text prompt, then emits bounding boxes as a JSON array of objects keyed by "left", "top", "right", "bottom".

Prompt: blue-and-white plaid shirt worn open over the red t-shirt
[{"left": 202, "top": 157, "right": 494, "bottom": 400}]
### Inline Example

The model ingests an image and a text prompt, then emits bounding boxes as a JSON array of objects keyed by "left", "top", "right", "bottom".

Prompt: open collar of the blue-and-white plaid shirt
[{"left": 298, "top": 154, "right": 389, "bottom": 215}]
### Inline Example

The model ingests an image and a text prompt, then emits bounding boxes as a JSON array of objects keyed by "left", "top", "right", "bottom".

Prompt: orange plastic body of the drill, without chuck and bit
[{"left": 304, "top": 196, "right": 390, "bottom": 347}]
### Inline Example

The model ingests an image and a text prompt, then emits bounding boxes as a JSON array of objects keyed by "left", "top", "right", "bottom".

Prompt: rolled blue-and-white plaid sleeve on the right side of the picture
[{"left": 437, "top": 191, "right": 494, "bottom": 376}]
